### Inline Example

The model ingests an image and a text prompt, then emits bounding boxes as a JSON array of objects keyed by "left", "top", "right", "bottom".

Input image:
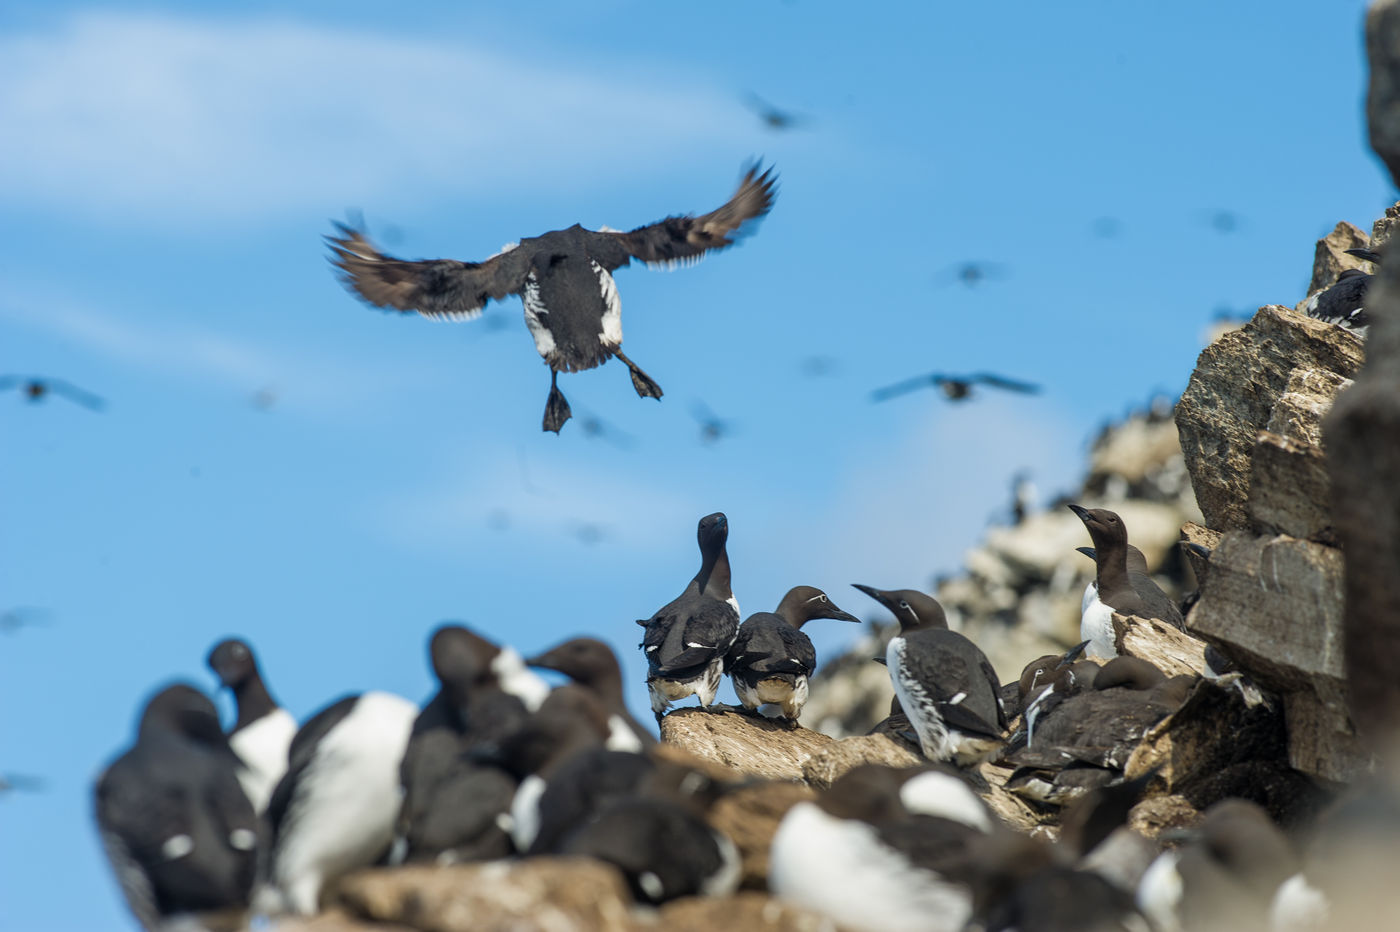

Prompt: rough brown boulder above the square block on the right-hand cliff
[{"left": 1176, "top": 305, "right": 1364, "bottom": 530}]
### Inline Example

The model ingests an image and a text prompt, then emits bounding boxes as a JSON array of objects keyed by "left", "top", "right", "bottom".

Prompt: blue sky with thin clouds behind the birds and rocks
[{"left": 0, "top": 0, "right": 1394, "bottom": 931}]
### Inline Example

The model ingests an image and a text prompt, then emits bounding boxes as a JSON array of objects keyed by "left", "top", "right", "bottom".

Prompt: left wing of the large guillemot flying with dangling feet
[{"left": 326, "top": 223, "right": 529, "bottom": 319}]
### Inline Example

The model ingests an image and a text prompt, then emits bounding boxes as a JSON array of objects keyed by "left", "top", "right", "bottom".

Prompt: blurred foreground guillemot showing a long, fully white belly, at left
[{"left": 258, "top": 693, "right": 419, "bottom": 915}]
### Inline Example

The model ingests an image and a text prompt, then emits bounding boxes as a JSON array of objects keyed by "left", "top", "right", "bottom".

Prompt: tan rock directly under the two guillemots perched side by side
[{"left": 661, "top": 708, "right": 832, "bottom": 779}]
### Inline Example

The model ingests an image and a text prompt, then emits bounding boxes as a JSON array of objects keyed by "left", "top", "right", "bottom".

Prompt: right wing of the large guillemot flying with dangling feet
[{"left": 596, "top": 165, "right": 778, "bottom": 271}]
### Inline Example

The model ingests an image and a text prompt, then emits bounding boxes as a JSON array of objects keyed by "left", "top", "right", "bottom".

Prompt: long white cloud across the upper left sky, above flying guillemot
[{"left": 0, "top": 13, "right": 749, "bottom": 223}]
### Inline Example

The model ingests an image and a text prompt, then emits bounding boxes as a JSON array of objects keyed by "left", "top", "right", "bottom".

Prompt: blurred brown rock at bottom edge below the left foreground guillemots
[{"left": 339, "top": 858, "right": 633, "bottom": 932}]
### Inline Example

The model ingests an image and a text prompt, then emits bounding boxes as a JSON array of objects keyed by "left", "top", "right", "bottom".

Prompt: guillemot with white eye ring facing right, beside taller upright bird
[{"left": 725, "top": 586, "right": 861, "bottom": 725}]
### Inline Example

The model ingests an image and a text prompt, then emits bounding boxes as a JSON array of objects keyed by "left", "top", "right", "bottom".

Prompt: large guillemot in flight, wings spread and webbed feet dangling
[{"left": 326, "top": 165, "right": 777, "bottom": 432}]
